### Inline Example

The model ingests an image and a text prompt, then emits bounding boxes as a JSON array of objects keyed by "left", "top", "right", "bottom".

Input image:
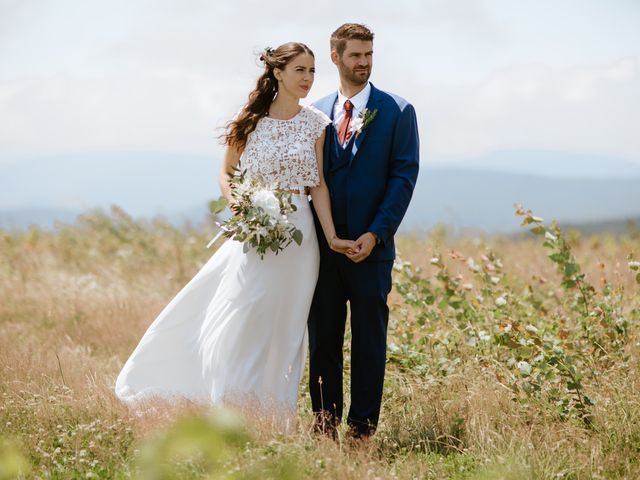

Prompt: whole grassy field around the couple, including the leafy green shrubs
[{"left": 0, "top": 208, "right": 640, "bottom": 480}]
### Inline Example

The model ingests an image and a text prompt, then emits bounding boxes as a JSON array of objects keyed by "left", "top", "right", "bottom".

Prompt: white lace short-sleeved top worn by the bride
[{"left": 240, "top": 107, "right": 331, "bottom": 190}]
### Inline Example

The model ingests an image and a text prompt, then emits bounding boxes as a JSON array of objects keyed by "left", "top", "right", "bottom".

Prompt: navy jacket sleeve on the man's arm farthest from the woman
[{"left": 368, "top": 104, "right": 420, "bottom": 244}]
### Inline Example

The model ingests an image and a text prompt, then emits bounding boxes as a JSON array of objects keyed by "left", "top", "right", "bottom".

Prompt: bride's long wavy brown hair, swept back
[{"left": 222, "top": 42, "right": 315, "bottom": 150}]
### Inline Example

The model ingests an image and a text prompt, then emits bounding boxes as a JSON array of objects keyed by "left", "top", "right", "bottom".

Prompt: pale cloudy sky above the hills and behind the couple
[{"left": 0, "top": 0, "right": 640, "bottom": 162}]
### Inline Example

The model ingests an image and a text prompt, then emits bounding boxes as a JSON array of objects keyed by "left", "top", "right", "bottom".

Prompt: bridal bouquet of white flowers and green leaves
[{"left": 207, "top": 171, "right": 302, "bottom": 259}]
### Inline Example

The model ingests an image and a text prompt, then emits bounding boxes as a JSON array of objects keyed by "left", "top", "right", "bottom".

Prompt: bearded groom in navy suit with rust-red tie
[{"left": 308, "top": 23, "right": 419, "bottom": 438}]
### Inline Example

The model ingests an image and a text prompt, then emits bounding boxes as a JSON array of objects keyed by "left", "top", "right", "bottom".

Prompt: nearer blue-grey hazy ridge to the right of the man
[{"left": 403, "top": 168, "right": 640, "bottom": 231}]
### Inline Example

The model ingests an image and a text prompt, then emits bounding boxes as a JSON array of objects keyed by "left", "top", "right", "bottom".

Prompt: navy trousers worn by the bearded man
[{"left": 308, "top": 225, "right": 393, "bottom": 436}]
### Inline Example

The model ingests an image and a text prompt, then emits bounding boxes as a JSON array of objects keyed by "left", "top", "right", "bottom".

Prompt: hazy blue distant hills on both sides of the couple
[{"left": 0, "top": 151, "right": 640, "bottom": 232}]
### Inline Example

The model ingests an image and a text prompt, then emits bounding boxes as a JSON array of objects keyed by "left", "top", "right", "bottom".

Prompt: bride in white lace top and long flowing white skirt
[{"left": 115, "top": 43, "right": 353, "bottom": 411}]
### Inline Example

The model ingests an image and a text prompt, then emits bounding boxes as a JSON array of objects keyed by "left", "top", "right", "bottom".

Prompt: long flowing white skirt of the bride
[{"left": 115, "top": 195, "right": 320, "bottom": 409}]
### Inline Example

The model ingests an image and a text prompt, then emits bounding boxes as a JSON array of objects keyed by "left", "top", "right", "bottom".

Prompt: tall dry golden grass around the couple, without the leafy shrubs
[{"left": 0, "top": 209, "right": 640, "bottom": 479}]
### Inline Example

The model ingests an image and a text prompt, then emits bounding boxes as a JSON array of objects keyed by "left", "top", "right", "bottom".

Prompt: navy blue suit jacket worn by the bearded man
[{"left": 313, "top": 84, "right": 420, "bottom": 261}]
